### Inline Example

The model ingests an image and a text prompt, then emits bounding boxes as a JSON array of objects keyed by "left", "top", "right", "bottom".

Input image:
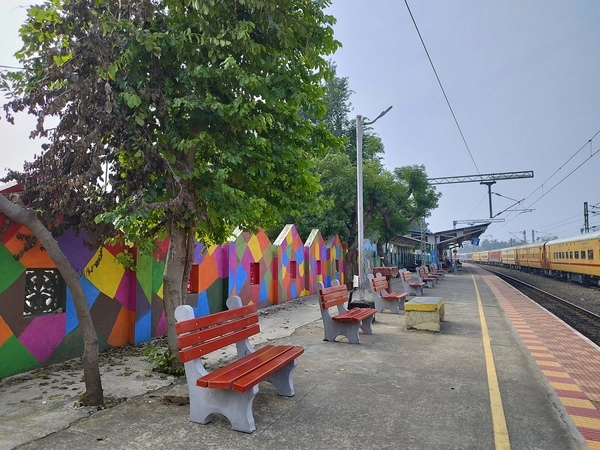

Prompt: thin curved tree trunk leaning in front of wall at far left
[{"left": 0, "top": 195, "right": 104, "bottom": 406}]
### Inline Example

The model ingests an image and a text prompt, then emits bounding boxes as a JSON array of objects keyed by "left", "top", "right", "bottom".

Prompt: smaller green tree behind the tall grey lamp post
[{"left": 278, "top": 63, "right": 441, "bottom": 283}]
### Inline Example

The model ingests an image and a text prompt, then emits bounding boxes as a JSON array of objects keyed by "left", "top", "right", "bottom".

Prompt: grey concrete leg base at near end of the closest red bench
[{"left": 188, "top": 380, "right": 258, "bottom": 433}]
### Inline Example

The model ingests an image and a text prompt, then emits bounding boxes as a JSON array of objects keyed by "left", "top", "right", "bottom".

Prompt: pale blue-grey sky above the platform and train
[{"left": 0, "top": 0, "right": 600, "bottom": 242}]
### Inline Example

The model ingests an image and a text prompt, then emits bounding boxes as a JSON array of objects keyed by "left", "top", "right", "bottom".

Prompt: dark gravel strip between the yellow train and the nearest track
[{"left": 478, "top": 266, "right": 600, "bottom": 315}]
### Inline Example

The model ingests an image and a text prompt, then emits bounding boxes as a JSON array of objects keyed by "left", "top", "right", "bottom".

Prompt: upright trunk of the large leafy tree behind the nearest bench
[{"left": 163, "top": 221, "right": 194, "bottom": 367}]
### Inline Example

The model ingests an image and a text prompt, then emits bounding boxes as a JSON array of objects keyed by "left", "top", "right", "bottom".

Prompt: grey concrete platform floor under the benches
[{"left": 0, "top": 270, "right": 585, "bottom": 450}]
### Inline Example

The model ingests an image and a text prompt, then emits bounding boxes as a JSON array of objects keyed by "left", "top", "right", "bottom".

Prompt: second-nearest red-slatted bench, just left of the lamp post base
[{"left": 315, "top": 280, "right": 377, "bottom": 344}]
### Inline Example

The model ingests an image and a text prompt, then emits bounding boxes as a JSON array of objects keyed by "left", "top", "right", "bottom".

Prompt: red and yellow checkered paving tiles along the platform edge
[{"left": 479, "top": 272, "right": 600, "bottom": 449}]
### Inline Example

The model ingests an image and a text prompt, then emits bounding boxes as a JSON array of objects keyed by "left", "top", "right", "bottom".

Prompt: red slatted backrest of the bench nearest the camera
[{"left": 175, "top": 305, "right": 260, "bottom": 363}]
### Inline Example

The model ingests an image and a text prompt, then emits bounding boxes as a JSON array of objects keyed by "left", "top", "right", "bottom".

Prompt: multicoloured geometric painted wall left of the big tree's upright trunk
[{"left": 0, "top": 224, "right": 166, "bottom": 377}]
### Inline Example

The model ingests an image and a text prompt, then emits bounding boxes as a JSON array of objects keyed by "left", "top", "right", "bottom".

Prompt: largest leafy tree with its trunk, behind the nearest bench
[{"left": 2, "top": 0, "right": 339, "bottom": 364}]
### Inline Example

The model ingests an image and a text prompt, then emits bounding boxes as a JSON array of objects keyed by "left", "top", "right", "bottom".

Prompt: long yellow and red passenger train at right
[{"left": 465, "top": 232, "right": 600, "bottom": 286}]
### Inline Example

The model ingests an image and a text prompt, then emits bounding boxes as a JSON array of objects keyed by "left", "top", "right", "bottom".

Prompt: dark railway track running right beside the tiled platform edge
[{"left": 483, "top": 266, "right": 600, "bottom": 345}]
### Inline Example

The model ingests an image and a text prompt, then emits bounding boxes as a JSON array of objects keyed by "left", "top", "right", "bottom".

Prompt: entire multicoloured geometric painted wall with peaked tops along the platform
[{"left": 0, "top": 215, "right": 344, "bottom": 378}]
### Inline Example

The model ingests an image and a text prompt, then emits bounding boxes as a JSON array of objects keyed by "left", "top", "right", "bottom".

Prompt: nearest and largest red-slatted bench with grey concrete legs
[{"left": 175, "top": 296, "right": 304, "bottom": 433}]
